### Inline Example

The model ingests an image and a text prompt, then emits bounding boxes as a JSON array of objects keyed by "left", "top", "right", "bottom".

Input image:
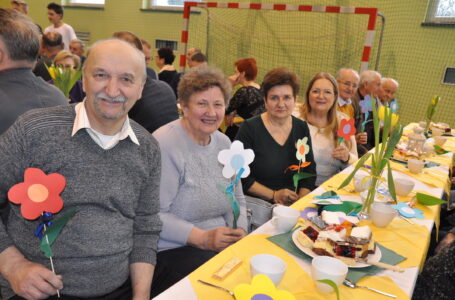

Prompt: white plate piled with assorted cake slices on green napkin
[{"left": 292, "top": 211, "right": 381, "bottom": 268}]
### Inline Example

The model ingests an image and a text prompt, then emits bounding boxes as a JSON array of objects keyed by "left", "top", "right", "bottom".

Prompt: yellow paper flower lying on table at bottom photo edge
[{"left": 234, "top": 274, "right": 295, "bottom": 300}]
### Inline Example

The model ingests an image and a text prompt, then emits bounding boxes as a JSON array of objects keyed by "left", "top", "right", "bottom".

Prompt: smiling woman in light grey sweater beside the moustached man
[{"left": 152, "top": 67, "right": 247, "bottom": 296}]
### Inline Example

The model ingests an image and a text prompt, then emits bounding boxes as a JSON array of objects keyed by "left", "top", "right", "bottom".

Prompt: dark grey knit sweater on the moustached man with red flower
[{"left": 0, "top": 106, "right": 161, "bottom": 299}]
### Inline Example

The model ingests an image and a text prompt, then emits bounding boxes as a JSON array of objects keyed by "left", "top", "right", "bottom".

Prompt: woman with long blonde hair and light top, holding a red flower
[{"left": 300, "top": 72, "right": 358, "bottom": 186}]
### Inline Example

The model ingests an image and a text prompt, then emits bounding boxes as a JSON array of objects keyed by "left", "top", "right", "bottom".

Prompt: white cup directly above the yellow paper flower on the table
[{"left": 250, "top": 254, "right": 286, "bottom": 285}]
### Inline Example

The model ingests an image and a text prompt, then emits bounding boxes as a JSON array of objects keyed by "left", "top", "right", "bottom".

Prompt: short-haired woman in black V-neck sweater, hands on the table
[{"left": 236, "top": 68, "right": 316, "bottom": 205}]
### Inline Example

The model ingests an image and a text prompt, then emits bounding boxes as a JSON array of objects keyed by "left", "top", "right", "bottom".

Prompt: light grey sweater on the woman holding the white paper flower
[{"left": 153, "top": 120, "right": 247, "bottom": 251}]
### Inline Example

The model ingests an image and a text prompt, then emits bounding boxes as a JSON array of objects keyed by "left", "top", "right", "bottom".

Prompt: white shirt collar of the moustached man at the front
[{"left": 71, "top": 99, "right": 139, "bottom": 150}]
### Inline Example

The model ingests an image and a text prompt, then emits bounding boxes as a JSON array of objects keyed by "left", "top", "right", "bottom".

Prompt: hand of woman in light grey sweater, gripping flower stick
[{"left": 203, "top": 227, "right": 246, "bottom": 252}]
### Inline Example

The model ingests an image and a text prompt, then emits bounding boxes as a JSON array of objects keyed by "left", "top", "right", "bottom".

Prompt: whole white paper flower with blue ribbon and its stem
[{"left": 217, "top": 141, "right": 254, "bottom": 229}]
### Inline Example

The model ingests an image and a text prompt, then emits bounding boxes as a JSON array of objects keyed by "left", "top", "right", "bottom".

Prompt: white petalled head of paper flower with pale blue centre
[{"left": 218, "top": 141, "right": 254, "bottom": 178}]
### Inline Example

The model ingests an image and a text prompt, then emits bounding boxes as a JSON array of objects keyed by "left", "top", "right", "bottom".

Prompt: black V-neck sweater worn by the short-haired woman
[{"left": 236, "top": 115, "right": 316, "bottom": 193}]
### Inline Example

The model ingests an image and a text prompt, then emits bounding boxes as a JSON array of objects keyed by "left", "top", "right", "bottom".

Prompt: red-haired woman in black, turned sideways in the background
[{"left": 225, "top": 58, "right": 265, "bottom": 140}]
